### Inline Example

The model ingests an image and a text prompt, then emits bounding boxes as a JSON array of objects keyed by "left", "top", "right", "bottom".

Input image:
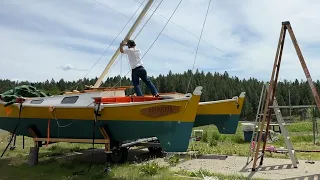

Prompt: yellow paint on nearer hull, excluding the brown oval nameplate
[{"left": 0, "top": 92, "right": 200, "bottom": 122}]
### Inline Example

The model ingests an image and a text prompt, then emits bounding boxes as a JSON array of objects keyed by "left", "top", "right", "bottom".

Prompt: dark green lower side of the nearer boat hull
[{"left": 0, "top": 118, "right": 193, "bottom": 152}]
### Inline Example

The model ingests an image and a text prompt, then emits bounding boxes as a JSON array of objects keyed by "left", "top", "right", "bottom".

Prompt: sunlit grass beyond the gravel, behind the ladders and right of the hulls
[{"left": 190, "top": 120, "right": 320, "bottom": 160}]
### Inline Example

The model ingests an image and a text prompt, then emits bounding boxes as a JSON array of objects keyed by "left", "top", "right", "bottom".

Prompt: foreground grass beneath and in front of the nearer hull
[{"left": 0, "top": 131, "right": 260, "bottom": 180}]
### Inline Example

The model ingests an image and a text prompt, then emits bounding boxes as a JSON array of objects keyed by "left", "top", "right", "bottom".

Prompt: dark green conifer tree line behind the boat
[{"left": 0, "top": 70, "right": 320, "bottom": 120}]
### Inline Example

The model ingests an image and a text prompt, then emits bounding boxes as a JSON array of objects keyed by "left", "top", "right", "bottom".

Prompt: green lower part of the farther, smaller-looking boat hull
[{"left": 193, "top": 114, "right": 240, "bottom": 134}]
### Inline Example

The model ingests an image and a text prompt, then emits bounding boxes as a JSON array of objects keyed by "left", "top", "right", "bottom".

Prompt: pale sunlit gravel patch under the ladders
[{"left": 169, "top": 155, "right": 320, "bottom": 180}]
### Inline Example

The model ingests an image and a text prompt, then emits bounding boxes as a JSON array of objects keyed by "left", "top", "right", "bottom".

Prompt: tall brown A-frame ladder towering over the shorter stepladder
[{"left": 252, "top": 21, "right": 320, "bottom": 171}]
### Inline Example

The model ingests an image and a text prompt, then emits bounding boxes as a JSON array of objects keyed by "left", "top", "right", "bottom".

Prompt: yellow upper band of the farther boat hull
[{"left": 197, "top": 97, "right": 245, "bottom": 115}]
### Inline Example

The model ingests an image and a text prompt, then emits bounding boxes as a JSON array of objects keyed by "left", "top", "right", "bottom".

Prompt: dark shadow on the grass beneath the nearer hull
[{"left": 0, "top": 145, "right": 165, "bottom": 180}]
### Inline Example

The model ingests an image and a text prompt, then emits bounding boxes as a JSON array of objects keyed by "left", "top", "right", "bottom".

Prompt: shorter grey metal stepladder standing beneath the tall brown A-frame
[{"left": 247, "top": 84, "right": 299, "bottom": 168}]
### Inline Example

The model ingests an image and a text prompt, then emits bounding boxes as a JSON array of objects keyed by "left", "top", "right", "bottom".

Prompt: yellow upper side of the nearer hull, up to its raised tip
[{"left": 0, "top": 88, "right": 200, "bottom": 122}]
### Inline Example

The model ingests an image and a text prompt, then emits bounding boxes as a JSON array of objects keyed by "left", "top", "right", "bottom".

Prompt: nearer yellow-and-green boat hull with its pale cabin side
[{"left": 0, "top": 87, "right": 202, "bottom": 152}]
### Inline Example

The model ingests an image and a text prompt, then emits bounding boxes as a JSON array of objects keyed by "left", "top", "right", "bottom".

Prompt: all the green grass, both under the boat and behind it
[{"left": 0, "top": 121, "right": 320, "bottom": 180}]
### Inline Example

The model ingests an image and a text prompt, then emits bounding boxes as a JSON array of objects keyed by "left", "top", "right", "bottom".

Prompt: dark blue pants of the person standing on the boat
[{"left": 131, "top": 66, "right": 158, "bottom": 96}]
